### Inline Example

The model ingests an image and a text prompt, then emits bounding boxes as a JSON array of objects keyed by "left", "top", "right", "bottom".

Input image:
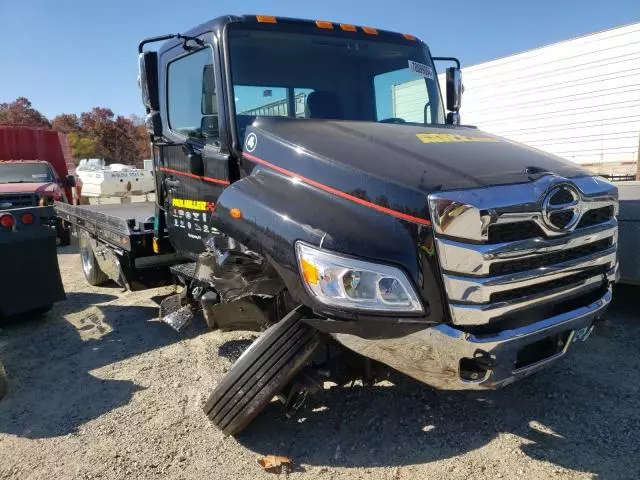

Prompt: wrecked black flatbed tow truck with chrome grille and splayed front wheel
[{"left": 56, "top": 15, "right": 618, "bottom": 434}]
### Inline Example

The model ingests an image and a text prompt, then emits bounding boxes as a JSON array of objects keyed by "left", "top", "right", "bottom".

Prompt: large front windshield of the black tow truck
[{"left": 229, "top": 27, "right": 444, "bottom": 142}]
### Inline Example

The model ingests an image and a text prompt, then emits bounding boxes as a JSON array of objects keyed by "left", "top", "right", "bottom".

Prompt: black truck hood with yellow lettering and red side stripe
[{"left": 243, "top": 118, "right": 589, "bottom": 223}]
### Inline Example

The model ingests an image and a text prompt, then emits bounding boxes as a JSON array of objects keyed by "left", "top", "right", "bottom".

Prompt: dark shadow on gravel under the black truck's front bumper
[{"left": 238, "top": 287, "right": 640, "bottom": 479}]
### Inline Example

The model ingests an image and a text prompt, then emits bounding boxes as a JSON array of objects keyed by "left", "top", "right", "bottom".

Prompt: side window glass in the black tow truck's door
[{"left": 167, "top": 47, "right": 219, "bottom": 142}]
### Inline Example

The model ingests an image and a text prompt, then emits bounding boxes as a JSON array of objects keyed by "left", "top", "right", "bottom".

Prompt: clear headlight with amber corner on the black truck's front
[{"left": 296, "top": 242, "right": 423, "bottom": 312}]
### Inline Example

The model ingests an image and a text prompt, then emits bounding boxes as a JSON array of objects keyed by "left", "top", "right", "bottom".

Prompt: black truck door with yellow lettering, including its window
[{"left": 158, "top": 39, "right": 230, "bottom": 257}]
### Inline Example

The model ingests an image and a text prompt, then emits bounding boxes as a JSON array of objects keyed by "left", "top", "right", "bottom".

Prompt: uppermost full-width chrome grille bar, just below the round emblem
[{"left": 436, "top": 218, "right": 618, "bottom": 276}]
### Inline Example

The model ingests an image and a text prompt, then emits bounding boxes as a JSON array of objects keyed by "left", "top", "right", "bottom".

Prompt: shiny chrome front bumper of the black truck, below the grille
[{"left": 332, "top": 282, "right": 617, "bottom": 390}]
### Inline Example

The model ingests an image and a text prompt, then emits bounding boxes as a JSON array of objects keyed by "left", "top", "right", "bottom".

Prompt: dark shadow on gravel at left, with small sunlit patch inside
[{"left": 0, "top": 292, "right": 180, "bottom": 438}]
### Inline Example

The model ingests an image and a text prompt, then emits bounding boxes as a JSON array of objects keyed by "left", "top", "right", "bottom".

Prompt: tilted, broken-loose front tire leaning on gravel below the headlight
[{"left": 204, "top": 307, "right": 319, "bottom": 435}]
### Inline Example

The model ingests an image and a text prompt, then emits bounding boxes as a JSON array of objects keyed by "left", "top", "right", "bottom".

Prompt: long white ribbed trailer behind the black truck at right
[{"left": 394, "top": 23, "right": 640, "bottom": 174}]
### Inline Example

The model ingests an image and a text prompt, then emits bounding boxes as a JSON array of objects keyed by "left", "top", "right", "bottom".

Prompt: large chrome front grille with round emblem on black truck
[{"left": 429, "top": 175, "right": 618, "bottom": 326}]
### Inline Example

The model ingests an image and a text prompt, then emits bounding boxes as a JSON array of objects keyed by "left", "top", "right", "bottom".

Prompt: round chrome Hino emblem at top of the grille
[{"left": 542, "top": 184, "right": 581, "bottom": 232}]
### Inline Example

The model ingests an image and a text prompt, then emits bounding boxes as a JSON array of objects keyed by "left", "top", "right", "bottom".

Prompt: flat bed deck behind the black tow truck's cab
[{"left": 54, "top": 202, "right": 156, "bottom": 250}]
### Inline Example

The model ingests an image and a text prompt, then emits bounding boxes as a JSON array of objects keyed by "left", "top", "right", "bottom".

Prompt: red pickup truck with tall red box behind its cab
[{"left": 0, "top": 126, "right": 75, "bottom": 245}]
